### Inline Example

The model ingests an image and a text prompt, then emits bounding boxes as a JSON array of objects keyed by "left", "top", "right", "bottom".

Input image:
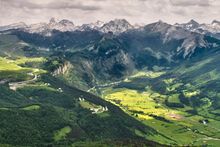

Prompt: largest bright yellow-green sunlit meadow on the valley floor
[{"left": 105, "top": 89, "right": 176, "bottom": 120}]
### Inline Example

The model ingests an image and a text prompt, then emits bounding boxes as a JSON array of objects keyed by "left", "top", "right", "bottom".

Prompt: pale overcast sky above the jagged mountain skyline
[{"left": 0, "top": 0, "right": 220, "bottom": 25}]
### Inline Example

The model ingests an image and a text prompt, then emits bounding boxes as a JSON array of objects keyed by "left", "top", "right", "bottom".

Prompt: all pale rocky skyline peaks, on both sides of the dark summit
[{"left": 0, "top": 18, "right": 220, "bottom": 34}]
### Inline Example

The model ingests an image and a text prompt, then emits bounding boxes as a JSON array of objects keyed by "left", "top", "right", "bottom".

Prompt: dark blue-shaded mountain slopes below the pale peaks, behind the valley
[{"left": 6, "top": 20, "right": 219, "bottom": 87}]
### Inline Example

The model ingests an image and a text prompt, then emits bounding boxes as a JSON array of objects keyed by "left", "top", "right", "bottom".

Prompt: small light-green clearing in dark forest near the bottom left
[{"left": 53, "top": 126, "right": 72, "bottom": 141}]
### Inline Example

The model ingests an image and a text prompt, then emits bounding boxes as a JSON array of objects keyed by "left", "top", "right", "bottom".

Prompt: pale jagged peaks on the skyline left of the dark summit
[{"left": 0, "top": 18, "right": 134, "bottom": 36}]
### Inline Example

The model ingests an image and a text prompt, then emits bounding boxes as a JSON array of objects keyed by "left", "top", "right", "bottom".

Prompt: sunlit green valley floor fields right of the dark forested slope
[{"left": 99, "top": 70, "right": 220, "bottom": 146}]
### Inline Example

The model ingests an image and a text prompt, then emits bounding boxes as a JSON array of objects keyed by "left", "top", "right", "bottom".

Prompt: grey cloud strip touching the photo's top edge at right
[{"left": 170, "top": 0, "right": 210, "bottom": 7}]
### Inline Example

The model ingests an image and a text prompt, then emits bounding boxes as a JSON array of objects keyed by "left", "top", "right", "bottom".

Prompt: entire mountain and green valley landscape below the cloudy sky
[{"left": 0, "top": 16, "right": 220, "bottom": 147}]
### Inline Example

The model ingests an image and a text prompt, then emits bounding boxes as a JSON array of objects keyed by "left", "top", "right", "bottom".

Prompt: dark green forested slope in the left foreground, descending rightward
[{"left": 0, "top": 53, "right": 164, "bottom": 146}]
